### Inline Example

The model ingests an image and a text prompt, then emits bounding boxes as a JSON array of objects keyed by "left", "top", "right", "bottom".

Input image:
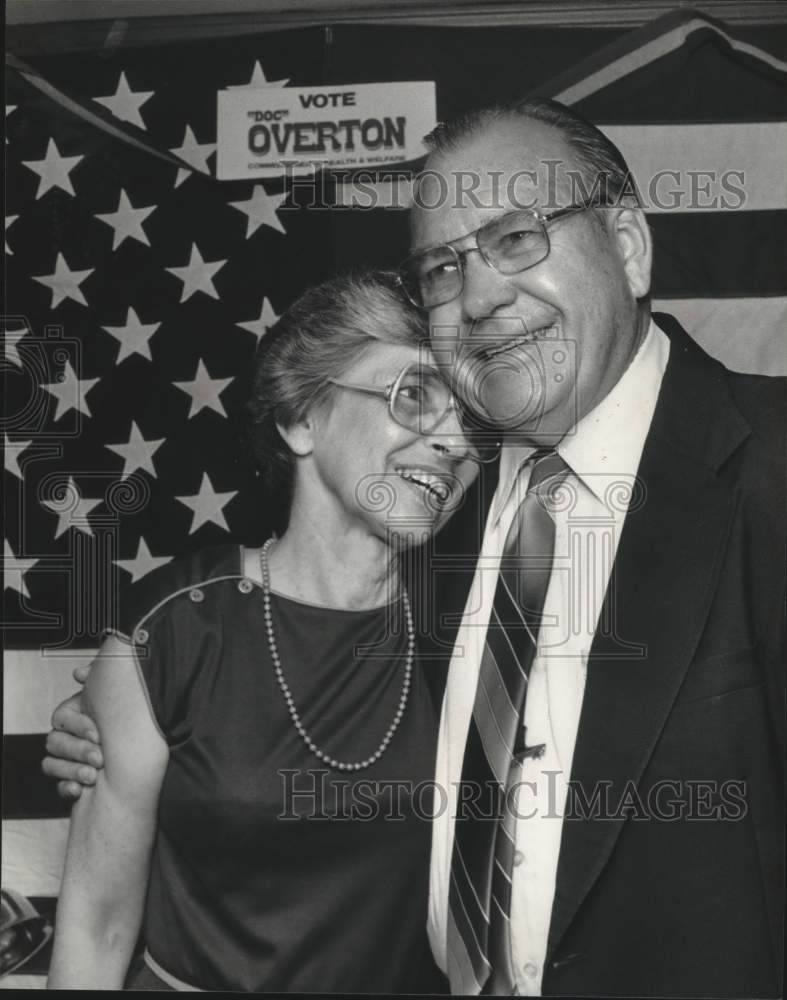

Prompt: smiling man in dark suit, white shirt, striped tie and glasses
[{"left": 48, "top": 101, "right": 785, "bottom": 996}]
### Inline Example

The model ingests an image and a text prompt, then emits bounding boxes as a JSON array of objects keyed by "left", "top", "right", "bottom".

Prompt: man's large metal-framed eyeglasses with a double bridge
[{"left": 399, "top": 205, "right": 595, "bottom": 309}]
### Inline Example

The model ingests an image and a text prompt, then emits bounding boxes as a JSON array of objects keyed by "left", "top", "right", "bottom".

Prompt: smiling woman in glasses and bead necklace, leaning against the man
[{"left": 44, "top": 274, "right": 476, "bottom": 993}]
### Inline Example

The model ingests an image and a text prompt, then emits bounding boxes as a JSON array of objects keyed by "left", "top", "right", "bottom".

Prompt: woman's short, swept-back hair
[{"left": 246, "top": 270, "right": 429, "bottom": 531}]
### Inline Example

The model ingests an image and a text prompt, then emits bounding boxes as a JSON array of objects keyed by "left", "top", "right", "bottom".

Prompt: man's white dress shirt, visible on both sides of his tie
[{"left": 429, "top": 322, "right": 669, "bottom": 996}]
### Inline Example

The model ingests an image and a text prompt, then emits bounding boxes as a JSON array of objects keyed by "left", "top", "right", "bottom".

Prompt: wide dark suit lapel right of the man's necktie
[{"left": 548, "top": 317, "right": 748, "bottom": 957}]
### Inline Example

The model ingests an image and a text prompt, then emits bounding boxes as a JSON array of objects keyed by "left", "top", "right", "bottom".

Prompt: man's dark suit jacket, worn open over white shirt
[{"left": 416, "top": 316, "right": 787, "bottom": 997}]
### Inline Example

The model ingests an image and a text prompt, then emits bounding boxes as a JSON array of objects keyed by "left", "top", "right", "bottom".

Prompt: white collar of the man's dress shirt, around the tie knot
[{"left": 490, "top": 320, "right": 669, "bottom": 524}]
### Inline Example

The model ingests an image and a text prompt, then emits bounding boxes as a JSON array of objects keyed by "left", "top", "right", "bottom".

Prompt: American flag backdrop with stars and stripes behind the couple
[{"left": 0, "top": 9, "right": 787, "bottom": 987}]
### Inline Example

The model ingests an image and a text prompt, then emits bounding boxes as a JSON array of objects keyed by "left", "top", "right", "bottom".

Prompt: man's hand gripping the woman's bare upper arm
[{"left": 41, "top": 665, "right": 104, "bottom": 800}]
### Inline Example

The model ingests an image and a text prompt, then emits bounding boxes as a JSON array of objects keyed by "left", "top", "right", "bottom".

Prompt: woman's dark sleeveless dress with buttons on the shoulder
[{"left": 120, "top": 546, "right": 444, "bottom": 993}]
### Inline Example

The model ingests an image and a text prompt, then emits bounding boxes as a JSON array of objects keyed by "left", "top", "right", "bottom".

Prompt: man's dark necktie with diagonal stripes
[{"left": 448, "top": 450, "right": 569, "bottom": 995}]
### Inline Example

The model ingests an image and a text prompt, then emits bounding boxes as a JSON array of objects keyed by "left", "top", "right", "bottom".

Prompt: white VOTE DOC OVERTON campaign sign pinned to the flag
[{"left": 217, "top": 81, "right": 436, "bottom": 180}]
